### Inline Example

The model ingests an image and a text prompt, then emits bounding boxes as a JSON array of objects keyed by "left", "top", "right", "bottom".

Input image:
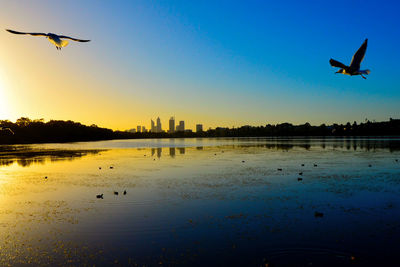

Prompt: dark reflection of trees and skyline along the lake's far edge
[{"left": 0, "top": 138, "right": 400, "bottom": 167}]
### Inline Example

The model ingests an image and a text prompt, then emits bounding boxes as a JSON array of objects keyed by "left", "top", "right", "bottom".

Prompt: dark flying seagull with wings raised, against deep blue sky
[{"left": 329, "top": 39, "right": 371, "bottom": 79}]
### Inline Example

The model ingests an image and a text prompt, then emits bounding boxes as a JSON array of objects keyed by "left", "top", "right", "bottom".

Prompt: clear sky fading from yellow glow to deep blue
[{"left": 0, "top": 0, "right": 400, "bottom": 130}]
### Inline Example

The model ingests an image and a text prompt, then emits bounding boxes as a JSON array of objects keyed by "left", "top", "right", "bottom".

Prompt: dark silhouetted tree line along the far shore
[{"left": 0, "top": 118, "right": 400, "bottom": 144}]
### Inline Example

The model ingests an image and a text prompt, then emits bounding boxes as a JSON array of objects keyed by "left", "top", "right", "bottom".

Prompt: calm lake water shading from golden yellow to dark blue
[{"left": 0, "top": 138, "right": 400, "bottom": 266}]
